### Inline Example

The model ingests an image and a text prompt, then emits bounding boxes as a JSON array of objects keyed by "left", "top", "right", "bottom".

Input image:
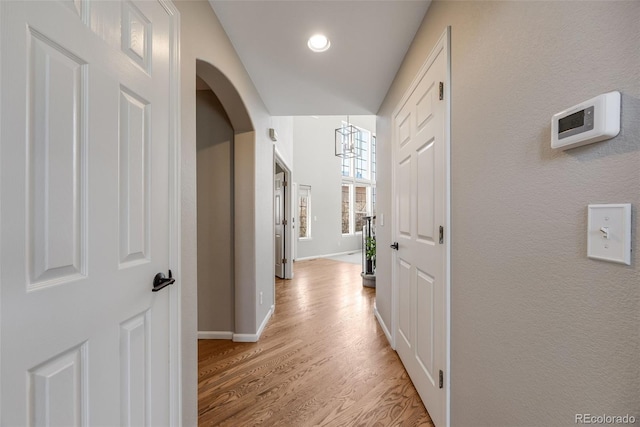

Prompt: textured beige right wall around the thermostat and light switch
[{"left": 377, "top": 1, "right": 640, "bottom": 426}]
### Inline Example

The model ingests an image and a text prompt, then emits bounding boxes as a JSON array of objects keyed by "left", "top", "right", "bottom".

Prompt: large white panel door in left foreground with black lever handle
[{"left": 0, "top": 0, "right": 177, "bottom": 426}]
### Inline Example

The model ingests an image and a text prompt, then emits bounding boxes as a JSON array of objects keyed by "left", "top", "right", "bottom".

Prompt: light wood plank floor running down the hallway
[{"left": 198, "top": 259, "right": 433, "bottom": 427}]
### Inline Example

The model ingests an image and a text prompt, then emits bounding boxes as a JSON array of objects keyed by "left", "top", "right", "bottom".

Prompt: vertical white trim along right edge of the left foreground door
[{"left": 158, "top": 0, "right": 182, "bottom": 426}]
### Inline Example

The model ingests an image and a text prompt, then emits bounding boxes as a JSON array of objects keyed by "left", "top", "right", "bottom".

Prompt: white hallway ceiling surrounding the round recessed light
[{"left": 209, "top": 0, "right": 430, "bottom": 116}]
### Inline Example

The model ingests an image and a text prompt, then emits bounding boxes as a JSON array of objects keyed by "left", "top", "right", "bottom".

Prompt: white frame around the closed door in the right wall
[{"left": 391, "top": 26, "right": 451, "bottom": 426}]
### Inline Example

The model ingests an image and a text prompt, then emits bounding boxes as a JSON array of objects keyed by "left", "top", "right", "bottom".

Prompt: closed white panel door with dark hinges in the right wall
[{"left": 393, "top": 30, "right": 448, "bottom": 426}]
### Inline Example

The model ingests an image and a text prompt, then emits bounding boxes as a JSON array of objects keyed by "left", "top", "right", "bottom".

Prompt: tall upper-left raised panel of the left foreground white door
[{"left": 27, "top": 28, "right": 87, "bottom": 290}]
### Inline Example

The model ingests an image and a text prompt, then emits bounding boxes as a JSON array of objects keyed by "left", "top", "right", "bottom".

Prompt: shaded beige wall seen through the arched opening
[{"left": 196, "top": 90, "right": 235, "bottom": 332}]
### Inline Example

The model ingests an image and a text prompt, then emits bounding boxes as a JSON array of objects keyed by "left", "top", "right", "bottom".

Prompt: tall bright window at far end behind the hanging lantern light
[{"left": 342, "top": 124, "right": 376, "bottom": 234}]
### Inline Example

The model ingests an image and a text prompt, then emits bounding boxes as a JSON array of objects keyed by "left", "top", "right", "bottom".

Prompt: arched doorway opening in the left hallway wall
[{"left": 196, "top": 60, "right": 255, "bottom": 339}]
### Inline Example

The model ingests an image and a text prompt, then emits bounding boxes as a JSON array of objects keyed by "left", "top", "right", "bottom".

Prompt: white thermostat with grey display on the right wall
[{"left": 551, "top": 91, "right": 620, "bottom": 150}]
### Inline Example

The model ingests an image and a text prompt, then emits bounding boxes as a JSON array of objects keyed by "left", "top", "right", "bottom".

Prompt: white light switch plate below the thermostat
[{"left": 587, "top": 203, "right": 631, "bottom": 265}]
